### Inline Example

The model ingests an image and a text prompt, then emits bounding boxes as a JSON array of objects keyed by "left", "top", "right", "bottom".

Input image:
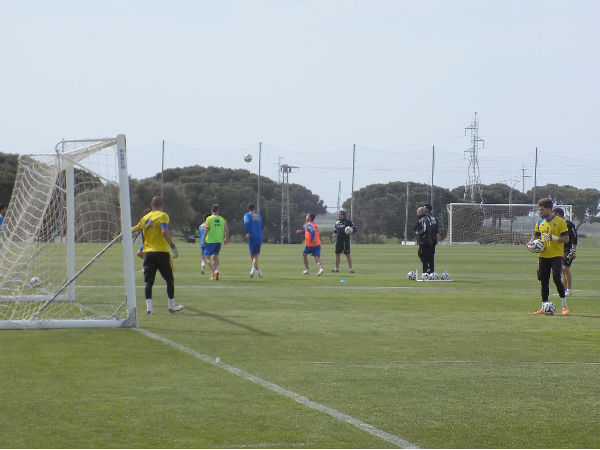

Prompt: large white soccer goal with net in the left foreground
[{"left": 0, "top": 135, "right": 136, "bottom": 329}]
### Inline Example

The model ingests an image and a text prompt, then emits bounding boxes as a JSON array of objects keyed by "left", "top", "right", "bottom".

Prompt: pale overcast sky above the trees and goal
[{"left": 0, "top": 0, "right": 600, "bottom": 206}]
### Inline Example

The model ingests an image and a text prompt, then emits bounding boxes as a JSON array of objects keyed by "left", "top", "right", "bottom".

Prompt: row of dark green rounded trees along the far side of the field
[{"left": 0, "top": 153, "right": 600, "bottom": 242}]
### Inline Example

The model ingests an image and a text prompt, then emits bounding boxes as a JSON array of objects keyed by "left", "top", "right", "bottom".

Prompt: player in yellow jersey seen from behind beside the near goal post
[{"left": 131, "top": 197, "right": 183, "bottom": 314}]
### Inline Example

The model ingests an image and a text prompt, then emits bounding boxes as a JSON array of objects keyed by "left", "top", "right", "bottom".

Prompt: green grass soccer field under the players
[{"left": 0, "top": 239, "right": 600, "bottom": 448}]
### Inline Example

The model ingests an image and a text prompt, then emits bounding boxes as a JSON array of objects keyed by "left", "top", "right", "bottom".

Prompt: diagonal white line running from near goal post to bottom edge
[{"left": 133, "top": 328, "right": 419, "bottom": 448}]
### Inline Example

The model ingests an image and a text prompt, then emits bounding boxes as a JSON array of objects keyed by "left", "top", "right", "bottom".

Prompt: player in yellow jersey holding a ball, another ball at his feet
[{"left": 531, "top": 198, "right": 569, "bottom": 316}]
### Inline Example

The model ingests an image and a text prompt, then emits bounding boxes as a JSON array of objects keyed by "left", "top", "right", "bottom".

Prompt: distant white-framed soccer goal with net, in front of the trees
[{"left": 447, "top": 203, "right": 572, "bottom": 245}]
